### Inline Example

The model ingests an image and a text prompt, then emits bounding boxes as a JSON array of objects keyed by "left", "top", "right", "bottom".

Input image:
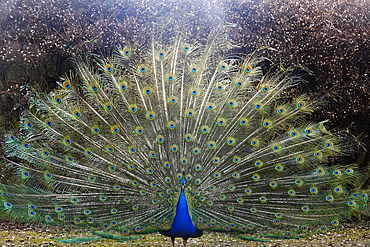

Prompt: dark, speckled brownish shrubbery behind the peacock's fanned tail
[{"left": 0, "top": 0, "right": 370, "bottom": 205}]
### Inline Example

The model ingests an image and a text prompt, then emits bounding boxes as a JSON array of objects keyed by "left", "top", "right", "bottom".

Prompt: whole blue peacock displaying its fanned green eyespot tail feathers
[{"left": 0, "top": 22, "right": 368, "bottom": 246}]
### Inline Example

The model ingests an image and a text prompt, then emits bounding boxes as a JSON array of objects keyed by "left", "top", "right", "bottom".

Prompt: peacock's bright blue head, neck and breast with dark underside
[{"left": 160, "top": 180, "right": 203, "bottom": 240}]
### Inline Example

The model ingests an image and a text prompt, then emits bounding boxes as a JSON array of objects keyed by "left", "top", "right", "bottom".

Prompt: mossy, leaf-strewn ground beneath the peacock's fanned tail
[{"left": 0, "top": 221, "right": 370, "bottom": 247}]
